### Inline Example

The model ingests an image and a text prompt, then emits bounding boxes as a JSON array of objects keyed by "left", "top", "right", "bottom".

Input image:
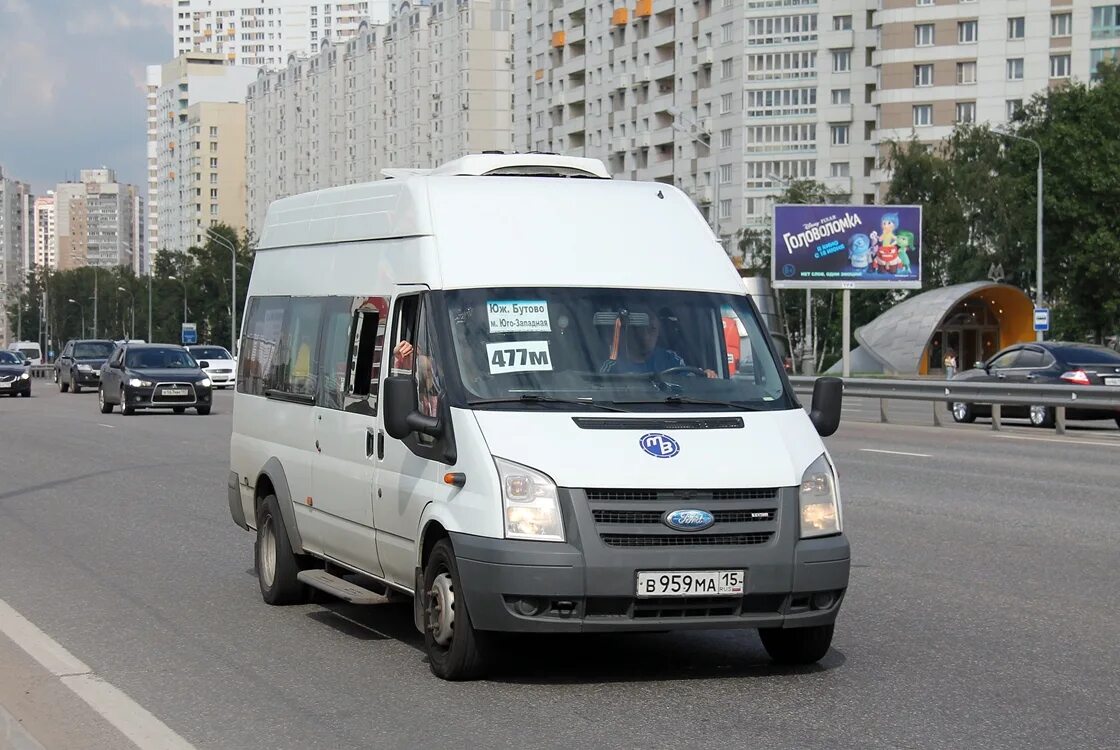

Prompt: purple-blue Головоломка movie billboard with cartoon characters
[{"left": 771, "top": 205, "right": 922, "bottom": 289}]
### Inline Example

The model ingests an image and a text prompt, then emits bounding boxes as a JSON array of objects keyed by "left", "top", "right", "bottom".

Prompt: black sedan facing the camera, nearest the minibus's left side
[{"left": 97, "top": 344, "right": 211, "bottom": 414}]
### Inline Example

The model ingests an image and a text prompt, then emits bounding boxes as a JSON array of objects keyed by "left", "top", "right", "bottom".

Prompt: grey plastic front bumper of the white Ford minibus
[{"left": 451, "top": 489, "right": 850, "bottom": 632}]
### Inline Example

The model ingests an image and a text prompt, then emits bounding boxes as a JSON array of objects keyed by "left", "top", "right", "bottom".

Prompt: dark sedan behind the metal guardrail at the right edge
[{"left": 949, "top": 341, "right": 1120, "bottom": 428}]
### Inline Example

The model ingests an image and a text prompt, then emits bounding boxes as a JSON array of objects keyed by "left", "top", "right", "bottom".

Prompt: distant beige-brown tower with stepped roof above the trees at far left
[{"left": 55, "top": 168, "right": 144, "bottom": 271}]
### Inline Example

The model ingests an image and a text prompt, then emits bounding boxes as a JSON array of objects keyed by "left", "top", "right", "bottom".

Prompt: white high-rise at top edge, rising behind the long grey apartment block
[{"left": 171, "top": 0, "right": 389, "bottom": 66}]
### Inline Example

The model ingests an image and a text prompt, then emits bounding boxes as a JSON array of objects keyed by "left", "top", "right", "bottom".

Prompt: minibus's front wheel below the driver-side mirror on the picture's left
[{"left": 417, "top": 538, "right": 492, "bottom": 681}]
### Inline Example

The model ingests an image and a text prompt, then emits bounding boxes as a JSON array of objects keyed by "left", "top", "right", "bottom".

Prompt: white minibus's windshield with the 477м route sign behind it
[{"left": 445, "top": 287, "right": 794, "bottom": 411}]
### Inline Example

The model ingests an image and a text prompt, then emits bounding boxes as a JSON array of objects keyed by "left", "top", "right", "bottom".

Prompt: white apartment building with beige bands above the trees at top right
[{"left": 872, "top": 0, "right": 1120, "bottom": 152}]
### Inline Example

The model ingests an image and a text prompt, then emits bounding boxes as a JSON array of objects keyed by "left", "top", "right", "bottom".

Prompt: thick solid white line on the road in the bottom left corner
[{"left": 0, "top": 599, "right": 194, "bottom": 750}]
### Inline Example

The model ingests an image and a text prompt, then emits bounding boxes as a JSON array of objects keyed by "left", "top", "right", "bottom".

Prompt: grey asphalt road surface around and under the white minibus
[{"left": 0, "top": 381, "right": 1120, "bottom": 750}]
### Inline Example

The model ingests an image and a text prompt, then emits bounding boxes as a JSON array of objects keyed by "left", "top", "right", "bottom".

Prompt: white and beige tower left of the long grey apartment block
[{"left": 149, "top": 53, "right": 258, "bottom": 253}]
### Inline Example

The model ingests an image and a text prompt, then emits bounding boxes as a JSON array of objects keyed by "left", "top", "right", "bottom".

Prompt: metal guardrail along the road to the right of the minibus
[{"left": 790, "top": 375, "right": 1120, "bottom": 434}]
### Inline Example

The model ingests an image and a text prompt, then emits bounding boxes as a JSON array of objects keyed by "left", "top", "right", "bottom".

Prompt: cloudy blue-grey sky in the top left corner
[{"left": 0, "top": 0, "right": 174, "bottom": 195}]
